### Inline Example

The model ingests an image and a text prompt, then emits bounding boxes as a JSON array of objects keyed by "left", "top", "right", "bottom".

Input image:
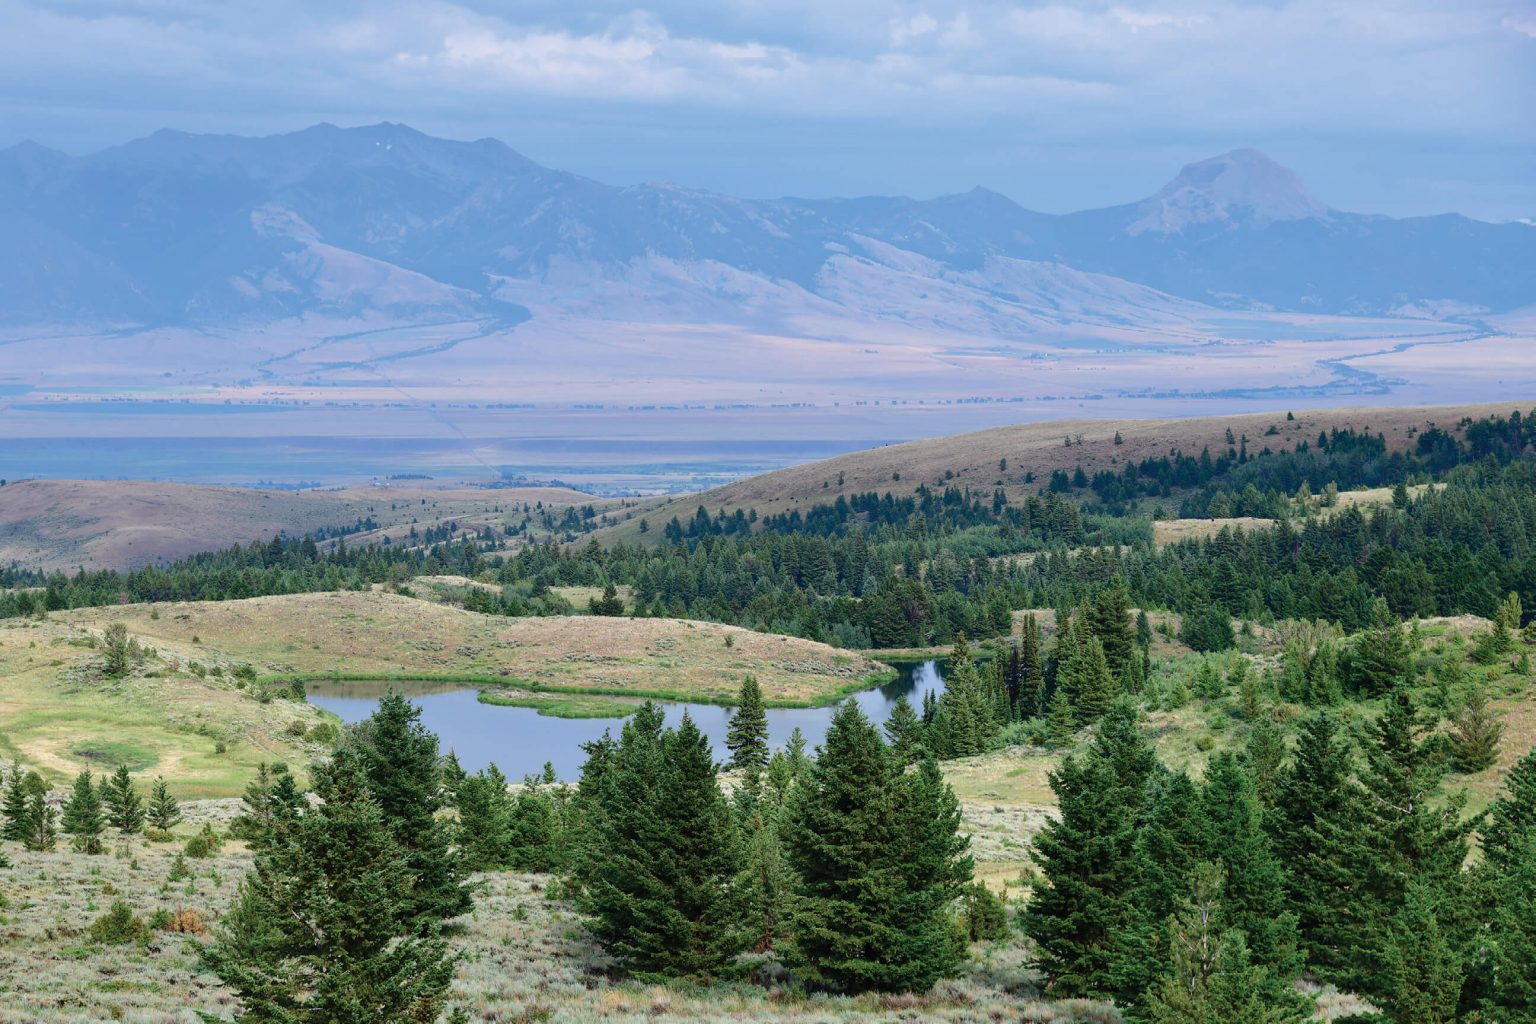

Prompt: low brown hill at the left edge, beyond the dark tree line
[{"left": 0, "top": 481, "right": 591, "bottom": 570}]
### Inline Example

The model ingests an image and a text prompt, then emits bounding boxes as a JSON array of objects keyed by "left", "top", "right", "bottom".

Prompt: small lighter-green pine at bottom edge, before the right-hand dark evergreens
[{"left": 1147, "top": 863, "right": 1310, "bottom": 1024}]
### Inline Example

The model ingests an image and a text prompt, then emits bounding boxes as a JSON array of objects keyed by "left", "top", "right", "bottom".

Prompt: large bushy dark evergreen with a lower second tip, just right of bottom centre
[{"left": 785, "top": 702, "right": 971, "bottom": 992}]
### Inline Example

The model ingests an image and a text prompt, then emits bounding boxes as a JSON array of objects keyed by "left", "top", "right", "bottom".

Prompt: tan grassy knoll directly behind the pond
[{"left": 68, "top": 591, "right": 883, "bottom": 703}]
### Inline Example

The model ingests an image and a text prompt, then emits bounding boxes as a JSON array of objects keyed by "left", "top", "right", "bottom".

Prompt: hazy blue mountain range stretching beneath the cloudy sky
[{"left": 0, "top": 124, "right": 1536, "bottom": 333}]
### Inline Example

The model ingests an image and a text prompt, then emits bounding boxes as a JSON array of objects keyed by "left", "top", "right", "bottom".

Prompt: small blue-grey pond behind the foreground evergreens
[{"left": 309, "top": 662, "right": 945, "bottom": 780}]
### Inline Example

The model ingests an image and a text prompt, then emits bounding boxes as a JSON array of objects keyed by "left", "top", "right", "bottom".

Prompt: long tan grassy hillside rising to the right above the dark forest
[{"left": 583, "top": 402, "right": 1530, "bottom": 543}]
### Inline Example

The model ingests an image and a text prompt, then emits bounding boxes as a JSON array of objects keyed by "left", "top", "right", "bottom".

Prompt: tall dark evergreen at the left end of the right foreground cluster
[{"left": 1025, "top": 705, "right": 1160, "bottom": 998}]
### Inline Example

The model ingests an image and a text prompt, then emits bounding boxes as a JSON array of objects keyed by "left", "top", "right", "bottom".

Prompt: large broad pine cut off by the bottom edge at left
[{"left": 200, "top": 749, "right": 456, "bottom": 1024}]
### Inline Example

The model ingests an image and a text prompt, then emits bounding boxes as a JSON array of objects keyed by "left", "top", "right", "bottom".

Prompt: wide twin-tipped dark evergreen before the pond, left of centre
[{"left": 585, "top": 712, "right": 754, "bottom": 981}]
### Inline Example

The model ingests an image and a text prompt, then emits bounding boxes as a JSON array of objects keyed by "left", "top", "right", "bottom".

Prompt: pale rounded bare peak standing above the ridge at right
[{"left": 1126, "top": 149, "right": 1329, "bottom": 235}]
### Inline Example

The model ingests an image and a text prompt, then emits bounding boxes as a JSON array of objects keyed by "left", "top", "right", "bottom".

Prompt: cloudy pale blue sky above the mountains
[{"left": 0, "top": 0, "right": 1536, "bottom": 220}]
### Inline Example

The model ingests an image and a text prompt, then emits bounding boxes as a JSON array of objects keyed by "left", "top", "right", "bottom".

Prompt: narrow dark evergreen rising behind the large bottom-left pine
[{"left": 349, "top": 691, "right": 473, "bottom": 933}]
